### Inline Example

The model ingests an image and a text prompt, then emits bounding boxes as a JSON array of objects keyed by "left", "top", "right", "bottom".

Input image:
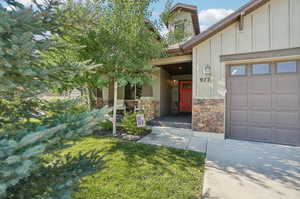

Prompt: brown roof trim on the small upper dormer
[{"left": 167, "top": 3, "right": 200, "bottom": 35}]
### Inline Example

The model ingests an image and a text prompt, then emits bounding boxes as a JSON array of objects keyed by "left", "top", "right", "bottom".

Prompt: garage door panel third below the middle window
[{"left": 248, "top": 111, "right": 272, "bottom": 125}]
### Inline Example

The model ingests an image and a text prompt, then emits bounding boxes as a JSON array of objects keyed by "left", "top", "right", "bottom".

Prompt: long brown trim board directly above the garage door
[{"left": 220, "top": 47, "right": 300, "bottom": 62}]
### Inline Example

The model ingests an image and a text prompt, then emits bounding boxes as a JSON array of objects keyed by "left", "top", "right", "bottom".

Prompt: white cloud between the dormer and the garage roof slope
[{"left": 198, "top": 9, "right": 234, "bottom": 31}]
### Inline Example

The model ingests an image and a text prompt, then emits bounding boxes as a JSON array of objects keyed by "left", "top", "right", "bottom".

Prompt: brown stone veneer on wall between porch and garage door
[{"left": 192, "top": 99, "right": 225, "bottom": 133}]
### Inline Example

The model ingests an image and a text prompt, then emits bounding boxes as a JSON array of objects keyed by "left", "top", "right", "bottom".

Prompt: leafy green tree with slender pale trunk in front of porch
[{"left": 49, "top": 0, "right": 164, "bottom": 134}]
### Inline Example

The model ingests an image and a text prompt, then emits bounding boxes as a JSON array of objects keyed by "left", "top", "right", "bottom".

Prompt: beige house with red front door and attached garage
[{"left": 102, "top": 0, "right": 300, "bottom": 146}]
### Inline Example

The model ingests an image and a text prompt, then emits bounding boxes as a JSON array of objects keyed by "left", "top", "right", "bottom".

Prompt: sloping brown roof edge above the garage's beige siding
[{"left": 177, "top": 0, "right": 270, "bottom": 52}]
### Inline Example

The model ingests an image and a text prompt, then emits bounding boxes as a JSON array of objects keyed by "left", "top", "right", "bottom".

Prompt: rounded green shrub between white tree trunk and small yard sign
[{"left": 121, "top": 113, "right": 147, "bottom": 135}]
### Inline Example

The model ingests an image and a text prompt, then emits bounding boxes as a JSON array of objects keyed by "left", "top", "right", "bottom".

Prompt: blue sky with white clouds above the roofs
[{"left": 9, "top": 0, "right": 251, "bottom": 31}]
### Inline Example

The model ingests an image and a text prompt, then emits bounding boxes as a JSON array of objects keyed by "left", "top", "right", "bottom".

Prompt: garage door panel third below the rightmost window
[{"left": 272, "top": 112, "right": 300, "bottom": 128}]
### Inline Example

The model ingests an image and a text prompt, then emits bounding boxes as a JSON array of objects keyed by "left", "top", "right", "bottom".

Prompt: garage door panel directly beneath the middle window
[{"left": 248, "top": 77, "right": 272, "bottom": 93}]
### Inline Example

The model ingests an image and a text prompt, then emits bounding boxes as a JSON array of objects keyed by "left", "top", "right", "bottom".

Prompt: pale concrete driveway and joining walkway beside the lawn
[{"left": 140, "top": 127, "right": 300, "bottom": 199}]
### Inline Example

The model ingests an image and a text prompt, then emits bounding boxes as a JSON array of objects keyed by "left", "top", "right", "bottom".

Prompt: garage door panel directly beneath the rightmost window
[{"left": 272, "top": 75, "right": 299, "bottom": 94}]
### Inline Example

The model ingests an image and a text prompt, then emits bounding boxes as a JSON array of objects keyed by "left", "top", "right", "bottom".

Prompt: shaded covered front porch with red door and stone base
[{"left": 102, "top": 55, "right": 192, "bottom": 122}]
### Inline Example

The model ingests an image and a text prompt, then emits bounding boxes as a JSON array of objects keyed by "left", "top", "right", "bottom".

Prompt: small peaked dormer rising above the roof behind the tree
[{"left": 166, "top": 3, "right": 200, "bottom": 40}]
